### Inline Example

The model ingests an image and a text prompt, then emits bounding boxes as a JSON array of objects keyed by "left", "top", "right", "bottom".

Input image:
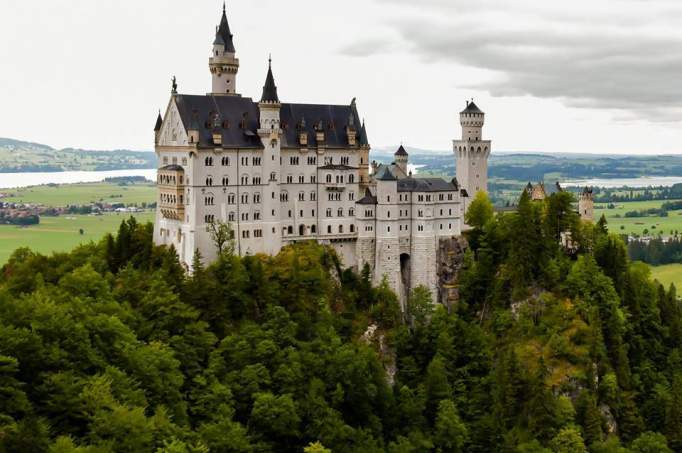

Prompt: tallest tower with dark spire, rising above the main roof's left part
[{"left": 208, "top": 3, "right": 239, "bottom": 96}]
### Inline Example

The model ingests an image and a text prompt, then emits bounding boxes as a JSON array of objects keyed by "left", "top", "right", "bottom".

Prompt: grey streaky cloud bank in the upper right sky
[{"left": 347, "top": 0, "right": 682, "bottom": 121}]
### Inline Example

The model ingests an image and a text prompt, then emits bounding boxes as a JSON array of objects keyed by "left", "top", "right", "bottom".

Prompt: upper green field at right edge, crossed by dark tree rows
[{"left": 594, "top": 200, "right": 682, "bottom": 235}]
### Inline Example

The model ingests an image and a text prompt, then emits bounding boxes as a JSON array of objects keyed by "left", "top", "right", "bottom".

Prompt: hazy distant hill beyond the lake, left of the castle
[{"left": 0, "top": 138, "right": 156, "bottom": 173}]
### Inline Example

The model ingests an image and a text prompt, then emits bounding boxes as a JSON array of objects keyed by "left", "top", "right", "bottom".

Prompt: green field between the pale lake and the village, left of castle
[{"left": 0, "top": 183, "right": 156, "bottom": 207}]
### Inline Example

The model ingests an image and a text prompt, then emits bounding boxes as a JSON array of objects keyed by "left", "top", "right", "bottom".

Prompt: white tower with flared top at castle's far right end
[{"left": 453, "top": 101, "right": 490, "bottom": 198}]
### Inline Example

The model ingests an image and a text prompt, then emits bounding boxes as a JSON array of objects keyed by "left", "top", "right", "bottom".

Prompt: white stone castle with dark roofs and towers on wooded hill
[{"left": 154, "top": 6, "right": 490, "bottom": 301}]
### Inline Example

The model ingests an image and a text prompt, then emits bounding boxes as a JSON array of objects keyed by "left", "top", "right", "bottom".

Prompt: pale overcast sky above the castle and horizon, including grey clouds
[{"left": 0, "top": 0, "right": 682, "bottom": 154}]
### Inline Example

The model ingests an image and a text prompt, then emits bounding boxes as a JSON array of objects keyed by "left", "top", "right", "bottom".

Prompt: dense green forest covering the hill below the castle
[{"left": 0, "top": 192, "right": 682, "bottom": 453}]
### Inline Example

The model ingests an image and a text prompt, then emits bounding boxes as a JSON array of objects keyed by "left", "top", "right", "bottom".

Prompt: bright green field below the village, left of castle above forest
[{"left": 0, "top": 212, "right": 154, "bottom": 265}]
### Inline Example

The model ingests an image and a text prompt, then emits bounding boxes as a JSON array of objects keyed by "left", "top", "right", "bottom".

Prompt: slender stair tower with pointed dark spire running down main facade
[{"left": 258, "top": 59, "right": 282, "bottom": 254}]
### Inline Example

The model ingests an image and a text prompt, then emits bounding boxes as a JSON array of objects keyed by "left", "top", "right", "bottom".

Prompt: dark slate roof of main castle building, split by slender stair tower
[{"left": 175, "top": 94, "right": 362, "bottom": 148}]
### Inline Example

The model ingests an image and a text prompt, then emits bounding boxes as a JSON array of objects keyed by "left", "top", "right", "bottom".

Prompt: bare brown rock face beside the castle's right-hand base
[{"left": 436, "top": 236, "right": 469, "bottom": 309}]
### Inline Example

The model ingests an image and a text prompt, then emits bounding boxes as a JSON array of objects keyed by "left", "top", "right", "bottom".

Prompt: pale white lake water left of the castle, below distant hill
[{"left": 0, "top": 168, "right": 156, "bottom": 189}]
